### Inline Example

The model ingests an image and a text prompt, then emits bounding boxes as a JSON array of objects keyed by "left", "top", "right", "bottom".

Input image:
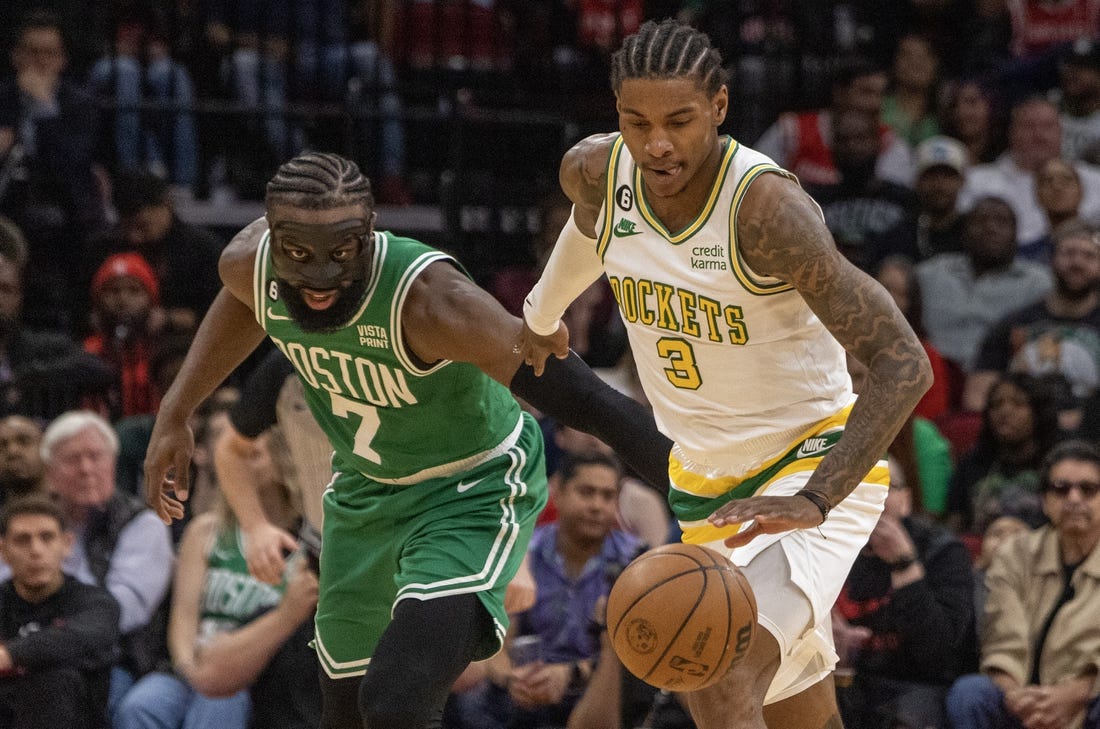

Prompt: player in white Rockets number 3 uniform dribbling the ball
[{"left": 523, "top": 15, "right": 932, "bottom": 729}]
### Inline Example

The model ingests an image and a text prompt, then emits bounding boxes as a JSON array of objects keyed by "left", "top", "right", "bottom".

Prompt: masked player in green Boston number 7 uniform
[{"left": 145, "top": 153, "right": 671, "bottom": 729}]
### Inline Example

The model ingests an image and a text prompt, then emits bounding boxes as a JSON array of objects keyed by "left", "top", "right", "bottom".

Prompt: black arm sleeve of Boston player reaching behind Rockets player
[{"left": 512, "top": 352, "right": 672, "bottom": 494}]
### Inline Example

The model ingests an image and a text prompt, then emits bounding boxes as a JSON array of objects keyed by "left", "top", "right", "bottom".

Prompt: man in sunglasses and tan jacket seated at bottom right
[{"left": 947, "top": 440, "right": 1100, "bottom": 729}]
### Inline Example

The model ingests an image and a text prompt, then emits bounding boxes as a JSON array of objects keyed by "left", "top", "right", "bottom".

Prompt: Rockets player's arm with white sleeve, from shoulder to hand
[{"left": 519, "top": 134, "right": 615, "bottom": 375}]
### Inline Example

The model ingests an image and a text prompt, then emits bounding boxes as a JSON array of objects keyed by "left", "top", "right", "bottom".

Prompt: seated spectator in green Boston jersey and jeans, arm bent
[{"left": 114, "top": 435, "right": 320, "bottom": 729}]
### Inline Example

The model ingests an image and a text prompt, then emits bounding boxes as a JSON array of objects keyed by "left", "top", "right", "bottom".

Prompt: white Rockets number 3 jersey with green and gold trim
[{"left": 596, "top": 136, "right": 853, "bottom": 475}]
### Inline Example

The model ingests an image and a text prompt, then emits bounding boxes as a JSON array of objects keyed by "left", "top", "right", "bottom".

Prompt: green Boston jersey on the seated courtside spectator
[{"left": 199, "top": 527, "right": 285, "bottom": 640}]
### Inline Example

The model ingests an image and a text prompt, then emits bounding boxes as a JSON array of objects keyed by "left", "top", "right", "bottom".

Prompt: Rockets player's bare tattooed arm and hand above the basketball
[{"left": 711, "top": 175, "right": 932, "bottom": 546}]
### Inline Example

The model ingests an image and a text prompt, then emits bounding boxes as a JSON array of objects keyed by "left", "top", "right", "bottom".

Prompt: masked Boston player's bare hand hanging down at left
[{"left": 145, "top": 417, "right": 195, "bottom": 524}]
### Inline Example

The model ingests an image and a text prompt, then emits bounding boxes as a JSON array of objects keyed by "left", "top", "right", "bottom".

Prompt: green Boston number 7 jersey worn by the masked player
[{"left": 253, "top": 232, "right": 520, "bottom": 484}]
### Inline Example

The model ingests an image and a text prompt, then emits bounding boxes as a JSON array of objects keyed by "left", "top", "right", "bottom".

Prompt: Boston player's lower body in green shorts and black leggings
[{"left": 316, "top": 416, "right": 547, "bottom": 729}]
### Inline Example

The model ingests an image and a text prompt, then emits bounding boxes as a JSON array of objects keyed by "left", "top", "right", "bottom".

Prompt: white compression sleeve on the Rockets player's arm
[{"left": 524, "top": 214, "right": 604, "bottom": 336}]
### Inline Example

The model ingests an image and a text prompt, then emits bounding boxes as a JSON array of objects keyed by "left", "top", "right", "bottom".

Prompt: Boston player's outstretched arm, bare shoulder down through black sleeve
[{"left": 402, "top": 262, "right": 672, "bottom": 493}]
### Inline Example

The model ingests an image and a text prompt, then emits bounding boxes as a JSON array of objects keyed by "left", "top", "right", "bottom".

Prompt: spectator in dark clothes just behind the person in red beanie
[{"left": 81, "top": 170, "right": 224, "bottom": 331}]
